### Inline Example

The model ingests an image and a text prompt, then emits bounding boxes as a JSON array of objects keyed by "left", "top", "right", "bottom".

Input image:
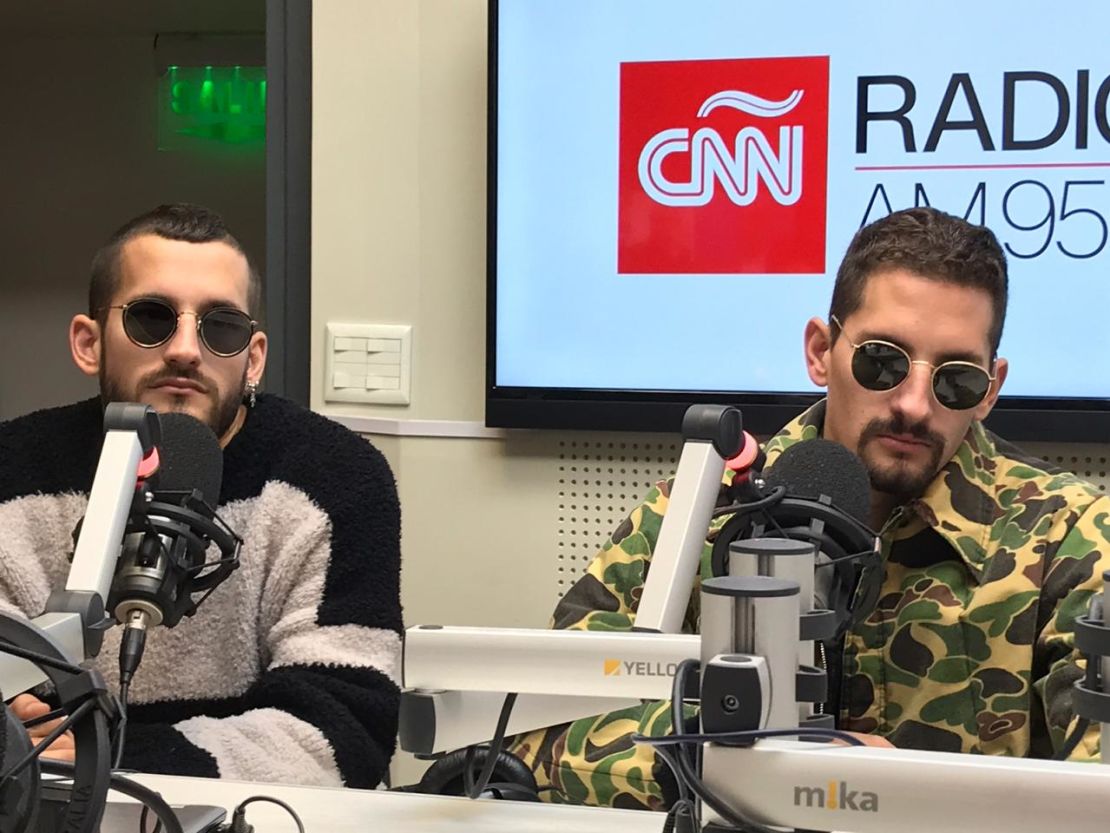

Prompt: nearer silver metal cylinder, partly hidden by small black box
[{"left": 702, "top": 575, "right": 800, "bottom": 729}]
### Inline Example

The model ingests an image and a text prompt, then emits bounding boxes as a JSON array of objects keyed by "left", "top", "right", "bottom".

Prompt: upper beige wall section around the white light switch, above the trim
[{"left": 312, "top": 0, "right": 486, "bottom": 420}]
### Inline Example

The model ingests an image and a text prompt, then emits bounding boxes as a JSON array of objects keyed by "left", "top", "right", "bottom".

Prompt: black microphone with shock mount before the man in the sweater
[{"left": 107, "top": 413, "right": 242, "bottom": 684}]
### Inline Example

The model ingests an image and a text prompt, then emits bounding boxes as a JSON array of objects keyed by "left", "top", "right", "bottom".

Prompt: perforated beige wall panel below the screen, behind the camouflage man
[{"left": 555, "top": 435, "right": 1110, "bottom": 596}]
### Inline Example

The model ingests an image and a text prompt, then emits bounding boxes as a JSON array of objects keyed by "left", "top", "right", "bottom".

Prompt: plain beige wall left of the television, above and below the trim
[{"left": 312, "top": 0, "right": 556, "bottom": 626}]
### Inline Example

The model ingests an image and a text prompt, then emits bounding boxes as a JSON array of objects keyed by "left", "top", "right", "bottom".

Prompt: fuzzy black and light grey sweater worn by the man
[{"left": 0, "top": 395, "right": 402, "bottom": 787}]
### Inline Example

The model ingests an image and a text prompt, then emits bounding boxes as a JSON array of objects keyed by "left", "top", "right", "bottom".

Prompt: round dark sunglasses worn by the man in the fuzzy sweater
[{"left": 104, "top": 298, "right": 259, "bottom": 358}]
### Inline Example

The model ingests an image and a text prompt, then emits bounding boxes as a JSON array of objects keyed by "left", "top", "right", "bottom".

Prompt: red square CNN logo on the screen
[{"left": 617, "top": 57, "right": 829, "bottom": 274}]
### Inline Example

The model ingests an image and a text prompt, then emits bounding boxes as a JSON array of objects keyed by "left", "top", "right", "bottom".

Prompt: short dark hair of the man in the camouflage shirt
[{"left": 829, "top": 208, "right": 1009, "bottom": 355}]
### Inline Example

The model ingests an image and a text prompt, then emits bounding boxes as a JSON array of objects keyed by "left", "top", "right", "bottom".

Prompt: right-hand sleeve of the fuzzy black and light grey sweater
[{"left": 123, "top": 435, "right": 401, "bottom": 787}]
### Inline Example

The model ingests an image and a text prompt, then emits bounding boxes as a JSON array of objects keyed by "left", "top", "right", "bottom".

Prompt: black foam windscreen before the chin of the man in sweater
[{"left": 154, "top": 413, "right": 223, "bottom": 508}]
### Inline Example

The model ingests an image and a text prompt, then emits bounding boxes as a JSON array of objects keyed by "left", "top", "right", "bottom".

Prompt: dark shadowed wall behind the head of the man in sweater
[{"left": 0, "top": 35, "right": 265, "bottom": 419}]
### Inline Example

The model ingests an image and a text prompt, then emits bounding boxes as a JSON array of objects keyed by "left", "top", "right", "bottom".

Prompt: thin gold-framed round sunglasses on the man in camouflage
[{"left": 833, "top": 315, "right": 996, "bottom": 411}]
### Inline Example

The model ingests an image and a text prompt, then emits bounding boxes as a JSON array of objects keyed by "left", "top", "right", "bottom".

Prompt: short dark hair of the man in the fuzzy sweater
[{"left": 89, "top": 202, "right": 262, "bottom": 321}]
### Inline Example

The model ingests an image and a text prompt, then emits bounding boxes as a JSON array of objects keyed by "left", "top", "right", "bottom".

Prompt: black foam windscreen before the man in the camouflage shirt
[{"left": 766, "top": 439, "right": 871, "bottom": 525}]
